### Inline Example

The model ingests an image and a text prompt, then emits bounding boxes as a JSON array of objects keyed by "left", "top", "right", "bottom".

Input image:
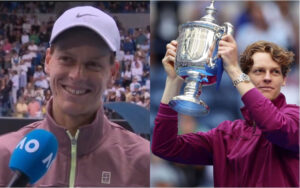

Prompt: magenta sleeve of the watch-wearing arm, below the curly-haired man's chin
[{"left": 242, "top": 88, "right": 299, "bottom": 152}]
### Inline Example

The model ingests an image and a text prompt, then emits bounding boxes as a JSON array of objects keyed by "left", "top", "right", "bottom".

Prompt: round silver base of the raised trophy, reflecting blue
[{"left": 169, "top": 95, "right": 209, "bottom": 116}]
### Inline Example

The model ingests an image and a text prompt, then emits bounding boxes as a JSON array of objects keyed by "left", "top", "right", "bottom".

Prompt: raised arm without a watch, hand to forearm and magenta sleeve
[{"left": 151, "top": 41, "right": 213, "bottom": 165}]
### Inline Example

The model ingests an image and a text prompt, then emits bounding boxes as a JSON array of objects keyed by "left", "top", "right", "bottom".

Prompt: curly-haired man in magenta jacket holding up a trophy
[{"left": 152, "top": 35, "right": 299, "bottom": 187}]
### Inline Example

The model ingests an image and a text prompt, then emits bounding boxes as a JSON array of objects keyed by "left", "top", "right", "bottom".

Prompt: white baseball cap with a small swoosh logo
[{"left": 50, "top": 6, "right": 120, "bottom": 52}]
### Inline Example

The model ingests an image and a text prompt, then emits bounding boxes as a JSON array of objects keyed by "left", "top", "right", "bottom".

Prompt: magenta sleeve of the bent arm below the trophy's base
[{"left": 151, "top": 103, "right": 214, "bottom": 165}]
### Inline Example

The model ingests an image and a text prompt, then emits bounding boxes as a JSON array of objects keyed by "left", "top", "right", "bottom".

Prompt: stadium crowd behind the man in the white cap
[{"left": 0, "top": 1, "right": 150, "bottom": 118}]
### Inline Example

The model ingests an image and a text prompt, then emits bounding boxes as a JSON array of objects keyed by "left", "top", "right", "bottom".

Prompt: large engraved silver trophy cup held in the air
[{"left": 169, "top": 0, "right": 233, "bottom": 116}]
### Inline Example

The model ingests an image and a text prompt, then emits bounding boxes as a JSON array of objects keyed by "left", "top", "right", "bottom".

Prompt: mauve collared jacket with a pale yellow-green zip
[{"left": 0, "top": 99, "right": 150, "bottom": 187}]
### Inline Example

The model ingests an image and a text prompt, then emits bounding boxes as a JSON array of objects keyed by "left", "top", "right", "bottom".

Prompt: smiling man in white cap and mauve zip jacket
[{"left": 0, "top": 6, "right": 150, "bottom": 187}]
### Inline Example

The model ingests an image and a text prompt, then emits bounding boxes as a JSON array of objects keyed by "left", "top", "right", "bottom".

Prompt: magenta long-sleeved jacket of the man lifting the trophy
[{"left": 152, "top": 88, "right": 299, "bottom": 187}]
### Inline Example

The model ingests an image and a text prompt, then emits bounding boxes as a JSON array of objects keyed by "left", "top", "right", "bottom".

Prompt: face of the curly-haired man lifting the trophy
[{"left": 248, "top": 52, "right": 286, "bottom": 100}]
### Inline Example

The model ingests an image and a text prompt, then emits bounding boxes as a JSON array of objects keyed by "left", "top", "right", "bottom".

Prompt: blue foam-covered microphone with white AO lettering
[{"left": 7, "top": 129, "right": 58, "bottom": 187}]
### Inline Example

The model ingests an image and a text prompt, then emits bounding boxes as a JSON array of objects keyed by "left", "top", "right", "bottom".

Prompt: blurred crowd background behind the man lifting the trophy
[{"left": 150, "top": 1, "right": 299, "bottom": 187}]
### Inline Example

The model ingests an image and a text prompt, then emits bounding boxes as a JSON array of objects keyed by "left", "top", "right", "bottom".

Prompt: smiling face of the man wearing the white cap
[{"left": 45, "top": 29, "right": 112, "bottom": 116}]
